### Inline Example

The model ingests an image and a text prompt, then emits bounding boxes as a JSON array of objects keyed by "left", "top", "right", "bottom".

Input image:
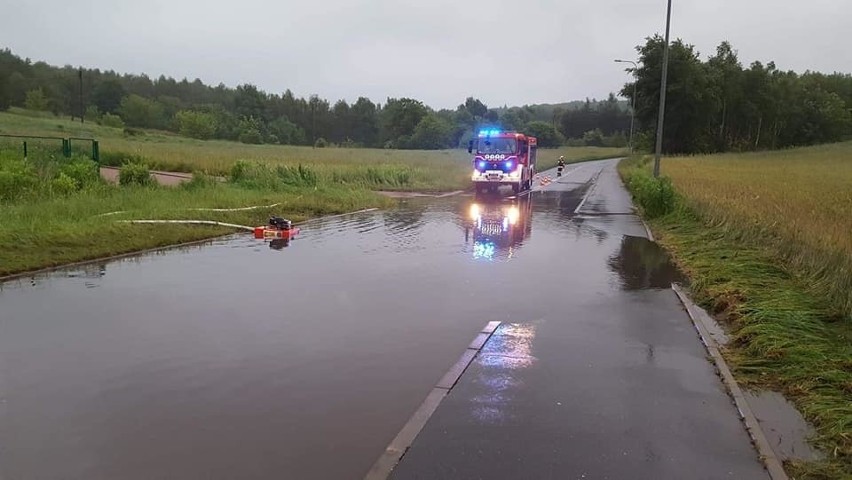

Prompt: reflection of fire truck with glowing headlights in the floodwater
[{"left": 465, "top": 196, "right": 532, "bottom": 259}]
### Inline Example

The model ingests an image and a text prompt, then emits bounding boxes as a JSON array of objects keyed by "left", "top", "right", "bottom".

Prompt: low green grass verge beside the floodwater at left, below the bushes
[{"left": 0, "top": 182, "right": 390, "bottom": 275}]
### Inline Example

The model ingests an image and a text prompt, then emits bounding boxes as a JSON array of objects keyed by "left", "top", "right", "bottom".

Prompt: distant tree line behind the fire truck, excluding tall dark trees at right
[{"left": 0, "top": 49, "right": 629, "bottom": 149}]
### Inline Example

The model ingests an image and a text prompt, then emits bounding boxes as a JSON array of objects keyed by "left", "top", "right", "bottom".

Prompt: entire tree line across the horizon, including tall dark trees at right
[{"left": 5, "top": 36, "right": 852, "bottom": 153}]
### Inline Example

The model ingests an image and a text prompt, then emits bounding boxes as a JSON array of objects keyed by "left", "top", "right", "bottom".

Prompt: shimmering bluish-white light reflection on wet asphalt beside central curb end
[{"left": 471, "top": 323, "right": 537, "bottom": 424}]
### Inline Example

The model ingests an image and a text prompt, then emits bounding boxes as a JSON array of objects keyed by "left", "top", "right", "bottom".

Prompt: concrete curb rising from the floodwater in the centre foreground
[{"left": 364, "top": 321, "right": 500, "bottom": 480}]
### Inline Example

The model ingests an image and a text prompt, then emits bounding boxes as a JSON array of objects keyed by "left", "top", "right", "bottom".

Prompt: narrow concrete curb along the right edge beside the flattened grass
[{"left": 672, "top": 284, "right": 789, "bottom": 480}]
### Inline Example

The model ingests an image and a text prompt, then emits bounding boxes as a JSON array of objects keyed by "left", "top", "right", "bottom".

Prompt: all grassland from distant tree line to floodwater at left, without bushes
[{"left": 0, "top": 110, "right": 621, "bottom": 276}]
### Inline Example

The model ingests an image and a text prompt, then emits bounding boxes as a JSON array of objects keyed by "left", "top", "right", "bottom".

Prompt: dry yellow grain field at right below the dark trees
[{"left": 662, "top": 142, "right": 852, "bottom": 314}]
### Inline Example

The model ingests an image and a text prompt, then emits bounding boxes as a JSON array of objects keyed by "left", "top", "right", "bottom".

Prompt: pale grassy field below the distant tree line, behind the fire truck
[{"left": 0, "top": 109, "right": 625, "bottom": 191}]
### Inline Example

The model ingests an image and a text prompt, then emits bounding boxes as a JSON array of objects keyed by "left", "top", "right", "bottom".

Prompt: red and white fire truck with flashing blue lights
[{"left": 467, "top": 130, "right": 538, "bottom": 193}]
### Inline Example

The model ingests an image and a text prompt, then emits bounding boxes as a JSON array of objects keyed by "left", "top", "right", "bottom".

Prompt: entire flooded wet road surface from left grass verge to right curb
[{"left": 0, "top": 161, "right": 765, "bottom": 480}]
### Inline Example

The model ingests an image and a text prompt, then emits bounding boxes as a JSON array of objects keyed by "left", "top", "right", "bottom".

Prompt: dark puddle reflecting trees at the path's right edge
[{"left": 607, "top": 235, "right": 686, "bottom": 290}]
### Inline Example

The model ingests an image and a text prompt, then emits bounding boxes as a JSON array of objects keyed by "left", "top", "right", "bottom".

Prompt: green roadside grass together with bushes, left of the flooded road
[{"left": 0, "top": 148, "right": 390, "bottom": 276}]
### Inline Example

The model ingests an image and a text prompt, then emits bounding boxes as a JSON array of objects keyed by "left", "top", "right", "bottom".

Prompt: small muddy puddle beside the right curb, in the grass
[{"left": 743, "top": 391, "right": 824, "bottom": 461}]
